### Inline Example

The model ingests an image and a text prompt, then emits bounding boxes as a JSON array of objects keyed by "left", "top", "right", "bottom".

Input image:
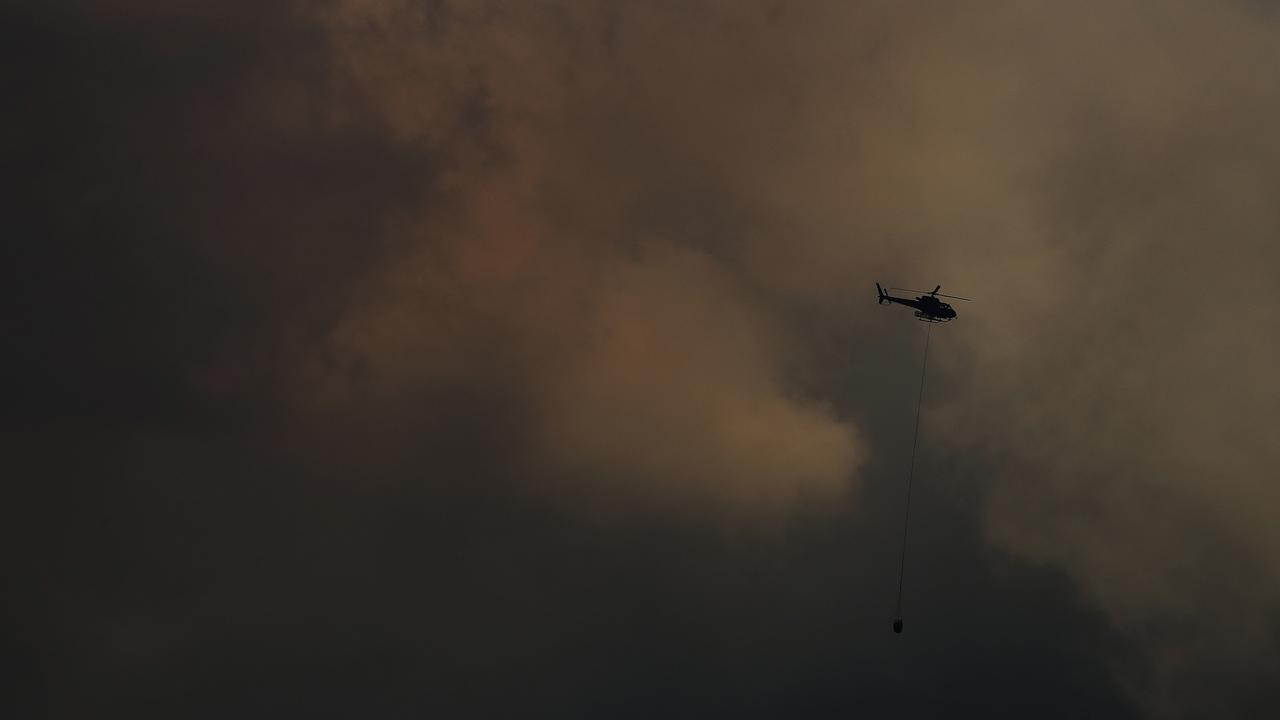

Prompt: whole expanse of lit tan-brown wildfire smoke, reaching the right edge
[{"left": 304, "top": 3, "right": 1280, "bottom": 710}]
